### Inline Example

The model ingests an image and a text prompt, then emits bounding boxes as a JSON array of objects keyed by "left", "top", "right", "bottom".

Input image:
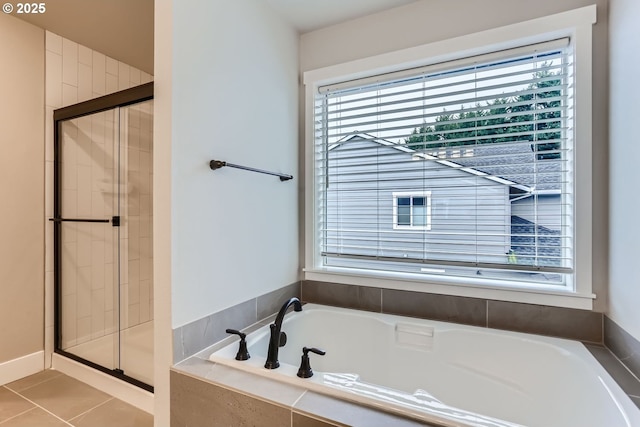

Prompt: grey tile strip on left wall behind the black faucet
[{"left": 173, "top": 282, "right": 300, "bottom": 363}]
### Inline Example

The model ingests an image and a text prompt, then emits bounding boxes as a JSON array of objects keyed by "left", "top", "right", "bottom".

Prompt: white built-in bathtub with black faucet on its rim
[{"left": 210, "top": 304, "right": 640, "bottom": 427}]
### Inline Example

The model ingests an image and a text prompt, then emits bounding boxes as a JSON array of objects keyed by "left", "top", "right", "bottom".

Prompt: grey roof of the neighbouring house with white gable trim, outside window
[{"left": 329, "top": 133, "right": 562, "bottom": 194}]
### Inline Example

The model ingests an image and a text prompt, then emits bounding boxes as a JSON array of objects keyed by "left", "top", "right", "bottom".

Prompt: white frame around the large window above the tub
[{"left": 304, "top": 5, "right": 596, "bottom": 309}]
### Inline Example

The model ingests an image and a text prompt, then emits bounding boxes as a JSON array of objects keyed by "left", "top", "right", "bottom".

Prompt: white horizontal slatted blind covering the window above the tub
[{"left": 314, "top": 39, "right": 574, "bottom": 285}]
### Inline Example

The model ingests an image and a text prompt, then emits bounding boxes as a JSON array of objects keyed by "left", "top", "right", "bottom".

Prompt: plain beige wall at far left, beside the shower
[{"left": 0, "top": 14, "right": 45, "bottom": 378}]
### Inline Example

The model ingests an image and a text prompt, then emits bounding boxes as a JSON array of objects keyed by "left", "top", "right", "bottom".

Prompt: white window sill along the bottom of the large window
[{"left": 303, "top": 267, "right": 596, "bottom": 310}]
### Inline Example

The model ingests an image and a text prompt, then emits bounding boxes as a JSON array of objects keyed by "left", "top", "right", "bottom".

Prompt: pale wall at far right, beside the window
[{"left": 608, "top": 0, "right": 640, "bottom": 344}]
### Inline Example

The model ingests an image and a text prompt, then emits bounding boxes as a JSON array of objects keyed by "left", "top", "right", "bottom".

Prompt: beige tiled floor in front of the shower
[{"left": 0, "top": 370, "right": 153, "bottom": 427}]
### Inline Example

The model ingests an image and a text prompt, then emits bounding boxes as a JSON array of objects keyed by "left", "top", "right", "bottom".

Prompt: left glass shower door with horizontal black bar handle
[{"left": 58, "top": 109, "right": 121, "bottom": 370}]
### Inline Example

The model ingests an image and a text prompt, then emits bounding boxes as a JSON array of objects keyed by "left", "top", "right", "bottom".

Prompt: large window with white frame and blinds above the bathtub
[{"left": 305, "top": 7, "right": 595, "bottom": 308}]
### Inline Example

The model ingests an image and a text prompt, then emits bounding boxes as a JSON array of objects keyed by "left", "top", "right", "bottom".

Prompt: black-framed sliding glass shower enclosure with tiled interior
[{"left": 51, "top": 83, "right": 153, "bottom": 391}]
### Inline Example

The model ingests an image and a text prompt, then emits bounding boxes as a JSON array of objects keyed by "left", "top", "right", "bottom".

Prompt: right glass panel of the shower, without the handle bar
[{"left": 119, "top": 100, "right": 153, "bottom": 384}]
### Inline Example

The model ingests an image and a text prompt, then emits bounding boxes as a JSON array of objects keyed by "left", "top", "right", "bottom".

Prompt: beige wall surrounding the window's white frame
[{"left": 300, "top": 0, "right": 608, "bottom": 312}]
